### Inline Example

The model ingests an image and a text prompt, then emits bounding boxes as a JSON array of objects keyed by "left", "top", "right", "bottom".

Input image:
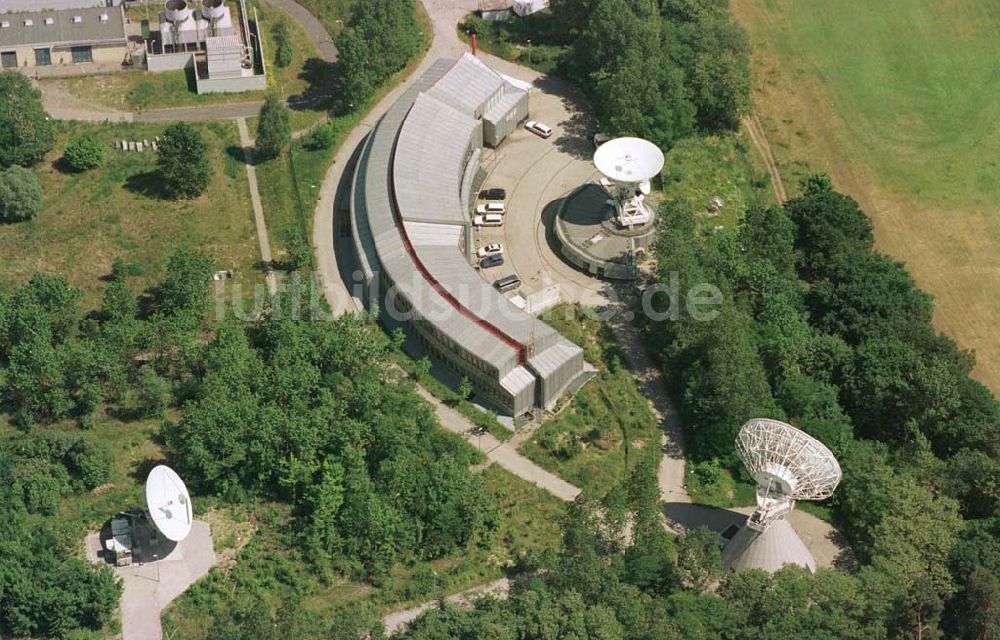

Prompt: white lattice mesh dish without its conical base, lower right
[{"left": 736, "top": 418, "right": 841, "bottom": 531}]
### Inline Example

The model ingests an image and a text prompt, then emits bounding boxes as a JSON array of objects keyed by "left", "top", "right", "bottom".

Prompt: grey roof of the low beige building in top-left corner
[{"left": 0, "top": 7, "right": 128, "bottom": 47}]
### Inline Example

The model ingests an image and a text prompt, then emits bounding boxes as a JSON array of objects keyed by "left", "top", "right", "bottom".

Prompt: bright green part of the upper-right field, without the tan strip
[{"left": 763, "top": 0, "right": 1000, "bottom": 206}]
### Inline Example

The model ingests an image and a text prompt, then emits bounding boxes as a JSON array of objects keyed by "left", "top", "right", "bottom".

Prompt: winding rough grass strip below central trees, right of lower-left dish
[{"left": 163, "top": 466, "right": 565, "bottom": 638}]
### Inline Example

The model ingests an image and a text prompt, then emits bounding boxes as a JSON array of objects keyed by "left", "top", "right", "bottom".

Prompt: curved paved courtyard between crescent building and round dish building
[{"left": 474, "top": 57, "right": 608, "bottom": 306}]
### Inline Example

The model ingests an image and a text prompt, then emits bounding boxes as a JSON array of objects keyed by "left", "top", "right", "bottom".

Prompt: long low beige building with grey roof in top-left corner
[{"left": 0, "top": 0, "right": 128, "bottom": 69}]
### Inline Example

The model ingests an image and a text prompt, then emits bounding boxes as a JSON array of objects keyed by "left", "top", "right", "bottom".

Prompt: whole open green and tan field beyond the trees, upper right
[{"left": 733, "top": 0, "right": 1000, "bottom": 392}]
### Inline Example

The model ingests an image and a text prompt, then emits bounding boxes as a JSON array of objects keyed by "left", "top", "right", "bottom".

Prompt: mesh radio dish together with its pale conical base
[{"left": 723, "top": 418, "right": 841, "bottom": 571}]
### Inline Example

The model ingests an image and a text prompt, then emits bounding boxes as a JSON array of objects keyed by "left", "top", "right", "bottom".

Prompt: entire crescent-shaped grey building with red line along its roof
[{"left": 350, "top": 54, "right": 586, "bottom": 422}]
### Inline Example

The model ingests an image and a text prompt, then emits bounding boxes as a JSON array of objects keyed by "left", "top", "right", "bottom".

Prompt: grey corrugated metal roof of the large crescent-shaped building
[{"left": 353, "top": 56, "right": 581, "bottom": 394}]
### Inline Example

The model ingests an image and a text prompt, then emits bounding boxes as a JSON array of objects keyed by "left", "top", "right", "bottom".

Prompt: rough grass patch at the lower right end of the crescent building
[{"left": 520, "top": 306, "right": 660, "bottom": 497}]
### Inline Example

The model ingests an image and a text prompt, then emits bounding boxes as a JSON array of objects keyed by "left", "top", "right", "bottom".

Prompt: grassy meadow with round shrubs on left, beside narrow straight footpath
[{"left": 0, "top": 122, "right": 263, "bottom": 306}]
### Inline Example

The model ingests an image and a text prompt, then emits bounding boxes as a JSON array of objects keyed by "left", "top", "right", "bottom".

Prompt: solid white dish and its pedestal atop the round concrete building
[{"left": 594, "top": 138, "right": 663, "bottom": 228}]
